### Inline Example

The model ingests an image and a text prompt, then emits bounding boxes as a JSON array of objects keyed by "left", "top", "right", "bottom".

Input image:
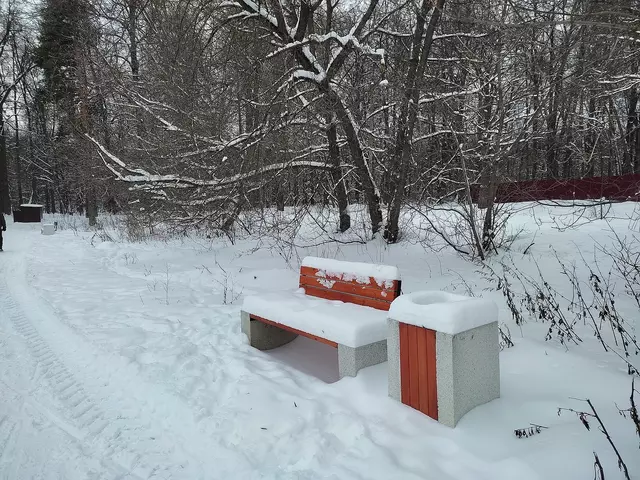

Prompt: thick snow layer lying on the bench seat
[{"left": 242, "top": 289, "right": 387, "bottom": 348}]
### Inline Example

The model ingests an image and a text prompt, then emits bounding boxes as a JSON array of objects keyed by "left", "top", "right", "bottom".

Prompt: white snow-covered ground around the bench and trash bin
[{"left": 0, "top": 204, "right": 640, "bottom": 480}]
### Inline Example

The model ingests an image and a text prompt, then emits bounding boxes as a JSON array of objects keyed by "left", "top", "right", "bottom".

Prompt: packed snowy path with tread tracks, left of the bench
[{"left": 0, "top": 232, "right": 254, "bottom": 478}]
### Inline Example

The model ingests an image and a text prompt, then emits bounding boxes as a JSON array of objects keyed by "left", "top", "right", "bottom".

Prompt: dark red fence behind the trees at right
[{"left": 472, "top": 174, "right": 640, "bottom": 203}]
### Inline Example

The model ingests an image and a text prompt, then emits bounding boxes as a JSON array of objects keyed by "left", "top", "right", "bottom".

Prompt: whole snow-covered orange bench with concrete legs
[{"left": 242, "top": 257, "right": 400, "bottom": 378}]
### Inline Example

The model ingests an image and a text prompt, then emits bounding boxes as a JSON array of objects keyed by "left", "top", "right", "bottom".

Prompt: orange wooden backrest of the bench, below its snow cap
[{"left": 300, "top": 266, "right": 400, "bottom": 310}]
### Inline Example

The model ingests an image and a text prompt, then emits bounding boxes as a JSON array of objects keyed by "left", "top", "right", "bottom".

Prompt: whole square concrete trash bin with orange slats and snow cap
[{"left": 387, "top": 292, "right": 500, "bottom": 427}]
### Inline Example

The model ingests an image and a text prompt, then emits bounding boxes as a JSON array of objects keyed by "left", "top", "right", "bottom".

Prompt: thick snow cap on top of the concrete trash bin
[{"left": 389, "top": 291, "right": 498, "bottom": 335}]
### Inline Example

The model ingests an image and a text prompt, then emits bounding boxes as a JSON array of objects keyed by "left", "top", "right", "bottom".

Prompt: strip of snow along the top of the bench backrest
[{"left": 302, "top": 257, "right": 400, "bottom": 288}]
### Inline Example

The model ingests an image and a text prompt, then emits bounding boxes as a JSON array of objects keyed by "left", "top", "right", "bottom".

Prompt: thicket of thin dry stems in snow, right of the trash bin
[{"left": 488, "top": 248, "right": 640, "bottom": 375}]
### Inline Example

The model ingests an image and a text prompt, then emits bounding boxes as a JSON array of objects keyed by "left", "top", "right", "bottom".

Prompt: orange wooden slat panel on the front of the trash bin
[{"left": 400, "top": 323, "right": 438, "bottom": 420}]
